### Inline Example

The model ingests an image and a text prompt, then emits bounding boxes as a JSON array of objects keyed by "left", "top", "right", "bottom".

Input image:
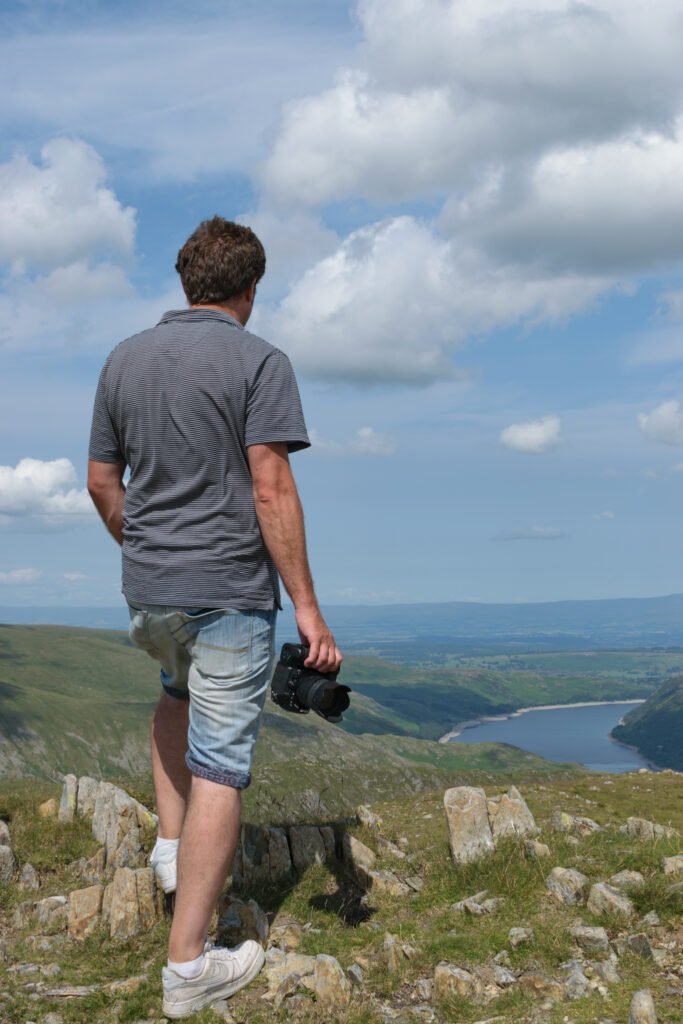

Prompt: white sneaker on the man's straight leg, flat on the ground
[{"left": 162, "top": 939, "right": 265, "bottom": 1020}]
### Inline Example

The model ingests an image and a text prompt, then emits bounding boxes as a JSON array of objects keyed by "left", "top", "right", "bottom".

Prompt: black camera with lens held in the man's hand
[{"left": 270, "top": 643, "right": 351, "bottom": 722}]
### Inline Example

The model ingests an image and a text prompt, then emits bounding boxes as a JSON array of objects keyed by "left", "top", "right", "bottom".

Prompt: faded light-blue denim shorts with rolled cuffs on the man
[{"left": 128, "top": 604, "right": 276, "bottom": 790}]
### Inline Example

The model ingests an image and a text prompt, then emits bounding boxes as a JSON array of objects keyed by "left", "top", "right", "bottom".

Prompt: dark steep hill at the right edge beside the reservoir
[{"left": 611, "top": 676, "right": 683, "bottom": 771}]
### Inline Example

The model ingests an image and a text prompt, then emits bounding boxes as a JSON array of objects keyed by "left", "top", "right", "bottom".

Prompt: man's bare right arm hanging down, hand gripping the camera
[{"left": 247, "top": 443, "right": 342, "bottom": 672}]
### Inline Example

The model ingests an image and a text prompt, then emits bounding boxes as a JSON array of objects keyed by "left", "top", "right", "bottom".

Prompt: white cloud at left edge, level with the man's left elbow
[{"left": 0, "top": 459, "right": 94, "bottom": 526}]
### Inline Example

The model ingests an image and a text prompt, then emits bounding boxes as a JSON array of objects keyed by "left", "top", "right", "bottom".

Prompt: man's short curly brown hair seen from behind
[{"left": 175, "top": 216, "right": 265, "bottom": 306}]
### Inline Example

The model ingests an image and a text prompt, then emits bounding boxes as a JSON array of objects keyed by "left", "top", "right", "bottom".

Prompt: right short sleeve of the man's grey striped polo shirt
[{"left": 245, "top": 348, "right": 310, "bottom": 452}]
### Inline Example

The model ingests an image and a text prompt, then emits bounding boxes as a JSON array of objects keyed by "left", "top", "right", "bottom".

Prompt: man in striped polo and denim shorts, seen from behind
[{"left": 88, "top": 217, "right": 342, "bottom": 1018}]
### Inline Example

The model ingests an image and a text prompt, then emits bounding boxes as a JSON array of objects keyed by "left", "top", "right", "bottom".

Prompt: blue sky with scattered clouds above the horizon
[{"left": 0, "top": 0, "right": 683, "bottom": 605}]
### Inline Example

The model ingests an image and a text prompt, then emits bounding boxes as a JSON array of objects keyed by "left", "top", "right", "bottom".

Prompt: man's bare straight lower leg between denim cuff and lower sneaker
[{"left": 168, "top": 776, "right": 241, "bottom": 964}]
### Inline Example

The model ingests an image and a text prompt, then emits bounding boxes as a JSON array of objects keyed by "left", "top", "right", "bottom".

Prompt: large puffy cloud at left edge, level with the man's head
[{"left": 0, "top": 138, "right": 135, "bottom": 269}]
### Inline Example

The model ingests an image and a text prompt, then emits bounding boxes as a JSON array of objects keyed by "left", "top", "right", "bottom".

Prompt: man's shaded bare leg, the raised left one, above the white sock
[{"left": 152, "top": 693, "right": 193, "bottom": 839}]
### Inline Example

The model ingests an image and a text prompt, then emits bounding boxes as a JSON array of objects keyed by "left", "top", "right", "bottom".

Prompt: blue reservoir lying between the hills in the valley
[{"left": 451, "top": 700, "right": 652, "bottom": 774}]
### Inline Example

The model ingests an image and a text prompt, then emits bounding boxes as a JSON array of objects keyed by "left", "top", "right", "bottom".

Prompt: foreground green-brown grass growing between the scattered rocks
[{"left": 0, "top": 774, "right": 683, "bottom": 1024}]
